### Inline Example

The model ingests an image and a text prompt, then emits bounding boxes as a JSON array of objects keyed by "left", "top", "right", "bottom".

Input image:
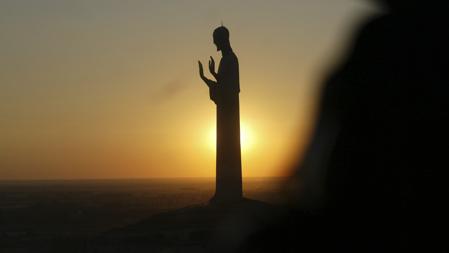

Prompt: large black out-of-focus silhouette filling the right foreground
[{"left": 243, "top": 0, "right": 449, "bottom": 252}]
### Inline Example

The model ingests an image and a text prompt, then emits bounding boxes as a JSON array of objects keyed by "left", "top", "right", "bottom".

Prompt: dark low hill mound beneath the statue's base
[{"left": 92, "top": 199, "right": 282, "bottom": 252}]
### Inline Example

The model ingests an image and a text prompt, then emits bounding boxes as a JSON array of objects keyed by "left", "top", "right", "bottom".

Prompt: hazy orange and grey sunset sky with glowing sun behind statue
[{"left": 0, "top": 0, "right": 374, "bottom": 179}]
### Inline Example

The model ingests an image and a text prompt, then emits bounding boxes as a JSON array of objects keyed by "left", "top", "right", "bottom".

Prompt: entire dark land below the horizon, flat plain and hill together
[{"left": 0, "top": 178, "right": 283, "bottom": 253}]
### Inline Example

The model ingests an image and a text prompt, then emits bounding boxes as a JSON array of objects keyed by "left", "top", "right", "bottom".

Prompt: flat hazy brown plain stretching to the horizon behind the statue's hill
[{"left": 0, "top": 178, "right": 283, "bottom": 252}]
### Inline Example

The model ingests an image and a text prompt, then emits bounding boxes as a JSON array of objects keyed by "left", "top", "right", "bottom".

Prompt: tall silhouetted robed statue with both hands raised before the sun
[{"left": 198, "top": 26, "right": 242, "bottom": 203}]
